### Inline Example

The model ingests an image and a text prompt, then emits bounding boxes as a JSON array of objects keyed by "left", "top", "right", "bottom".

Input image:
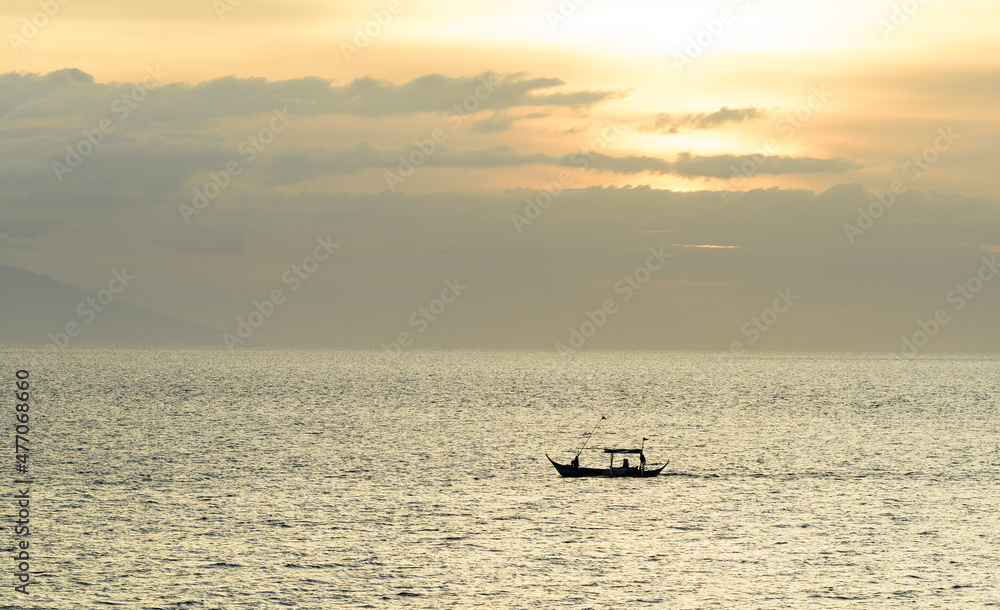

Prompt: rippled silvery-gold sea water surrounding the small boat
[{"left": 0, "top": 350, "right": 1000, "bottom": 609}]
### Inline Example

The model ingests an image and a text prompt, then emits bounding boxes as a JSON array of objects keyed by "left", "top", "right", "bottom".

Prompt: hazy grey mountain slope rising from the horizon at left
[{"left": 0, "top": 265, "right": 223, "bottom": 347}]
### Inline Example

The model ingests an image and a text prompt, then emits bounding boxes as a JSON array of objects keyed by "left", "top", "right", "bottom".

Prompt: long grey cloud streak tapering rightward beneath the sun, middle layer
[{"left": 0, "top": 134, "right": 862, "bottom": 198}]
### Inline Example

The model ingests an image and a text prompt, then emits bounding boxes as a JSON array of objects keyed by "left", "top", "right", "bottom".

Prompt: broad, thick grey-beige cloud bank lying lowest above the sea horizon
[{"left": 7, "top": 179, "right": 1000, "bottom": 350}]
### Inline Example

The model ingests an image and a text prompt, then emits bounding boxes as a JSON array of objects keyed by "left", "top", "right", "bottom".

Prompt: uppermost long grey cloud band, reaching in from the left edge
[{"left": 0, "top": 69, "right": 618, "bottom": 124}]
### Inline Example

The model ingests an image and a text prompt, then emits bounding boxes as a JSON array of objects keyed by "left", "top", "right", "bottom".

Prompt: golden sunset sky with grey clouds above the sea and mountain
[{"left": 0, "top": 0, "right": 1000, "bottom": 355}]
